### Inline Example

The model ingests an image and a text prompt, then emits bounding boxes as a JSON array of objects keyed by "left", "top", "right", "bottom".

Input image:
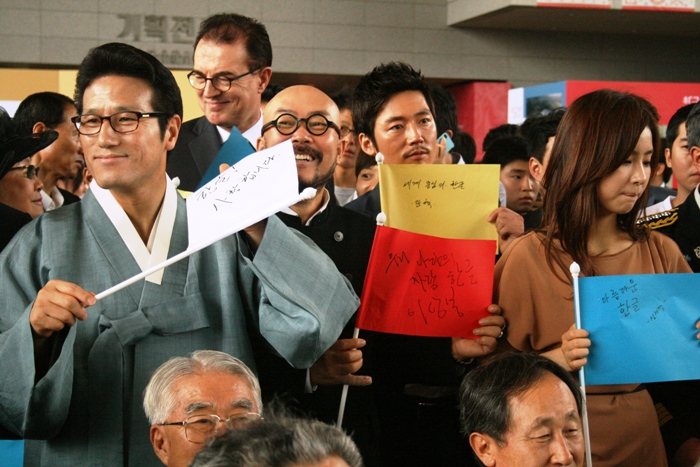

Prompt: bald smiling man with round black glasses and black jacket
[{"left": 257, "top": 86, "right": 377, "bottom": 464}]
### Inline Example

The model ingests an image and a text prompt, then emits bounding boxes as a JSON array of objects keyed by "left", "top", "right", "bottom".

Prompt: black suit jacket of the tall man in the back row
[{"left": 165, "top": 117, "right": 223, "bottom": 191}]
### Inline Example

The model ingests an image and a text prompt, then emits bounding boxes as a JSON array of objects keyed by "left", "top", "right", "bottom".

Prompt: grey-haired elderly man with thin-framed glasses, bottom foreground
[{"left": 143, "top": 350, "right": 262, "bottom": 467}]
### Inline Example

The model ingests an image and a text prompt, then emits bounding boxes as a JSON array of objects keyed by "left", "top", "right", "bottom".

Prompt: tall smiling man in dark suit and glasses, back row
[{"left": 166, "top": 13, "right": 272, "bottom": 191}]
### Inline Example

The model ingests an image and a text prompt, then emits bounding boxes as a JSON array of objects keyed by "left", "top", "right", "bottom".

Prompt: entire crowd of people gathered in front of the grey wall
[{"left": 0, "top": 13, "right": 700, "bottom": 467}]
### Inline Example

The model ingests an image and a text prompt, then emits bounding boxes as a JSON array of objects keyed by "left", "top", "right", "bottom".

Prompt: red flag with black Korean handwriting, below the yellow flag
[{"left": 357, "top": 227, "right": 496, "bottom": 339}]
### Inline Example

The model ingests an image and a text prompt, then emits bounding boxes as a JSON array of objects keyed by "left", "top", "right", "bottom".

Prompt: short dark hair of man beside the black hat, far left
[{"left": 14, "top": 92, "right": 75, "bottom": 135}]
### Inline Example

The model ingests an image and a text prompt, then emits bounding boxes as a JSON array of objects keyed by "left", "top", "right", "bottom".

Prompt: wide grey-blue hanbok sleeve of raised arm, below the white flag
[{"left": 239, "top": 216, "right": 360, "bottom": 368}]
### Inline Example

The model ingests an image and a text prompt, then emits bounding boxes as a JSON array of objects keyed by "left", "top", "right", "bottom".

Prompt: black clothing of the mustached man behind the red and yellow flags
[{"left": 344, "top": 185, "right": 472, "bottom": 466}]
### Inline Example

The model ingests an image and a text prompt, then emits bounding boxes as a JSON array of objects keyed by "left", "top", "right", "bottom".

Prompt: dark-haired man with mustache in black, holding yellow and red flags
[{"left": 346, "top": 62, "right": 508, "bottom": 466}]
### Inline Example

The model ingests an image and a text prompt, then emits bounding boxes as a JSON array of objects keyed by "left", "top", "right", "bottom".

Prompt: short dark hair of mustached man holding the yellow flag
[{"left": 352, "top": 62, "right": 435, "bottom": 146}]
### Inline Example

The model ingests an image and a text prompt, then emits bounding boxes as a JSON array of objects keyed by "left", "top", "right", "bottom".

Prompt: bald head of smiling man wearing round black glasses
[{"left": 258, "top": 86, "right": 343, "bottom": 189}]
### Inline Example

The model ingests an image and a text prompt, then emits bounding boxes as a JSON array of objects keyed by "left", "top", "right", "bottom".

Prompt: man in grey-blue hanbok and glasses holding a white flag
[{"left": 0, "top": 44, "right": 358, "bottom": 466}]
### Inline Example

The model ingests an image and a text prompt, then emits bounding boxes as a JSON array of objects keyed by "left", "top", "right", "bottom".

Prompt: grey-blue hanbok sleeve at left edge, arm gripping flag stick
[{"left": 0, "top": 222, "right": 75, "bottom": 439}]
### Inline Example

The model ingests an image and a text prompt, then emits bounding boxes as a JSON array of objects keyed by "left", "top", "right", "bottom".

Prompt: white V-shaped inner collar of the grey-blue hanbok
[{"left": 90, "top": 175, "right": 177, "bottom": 285}]
